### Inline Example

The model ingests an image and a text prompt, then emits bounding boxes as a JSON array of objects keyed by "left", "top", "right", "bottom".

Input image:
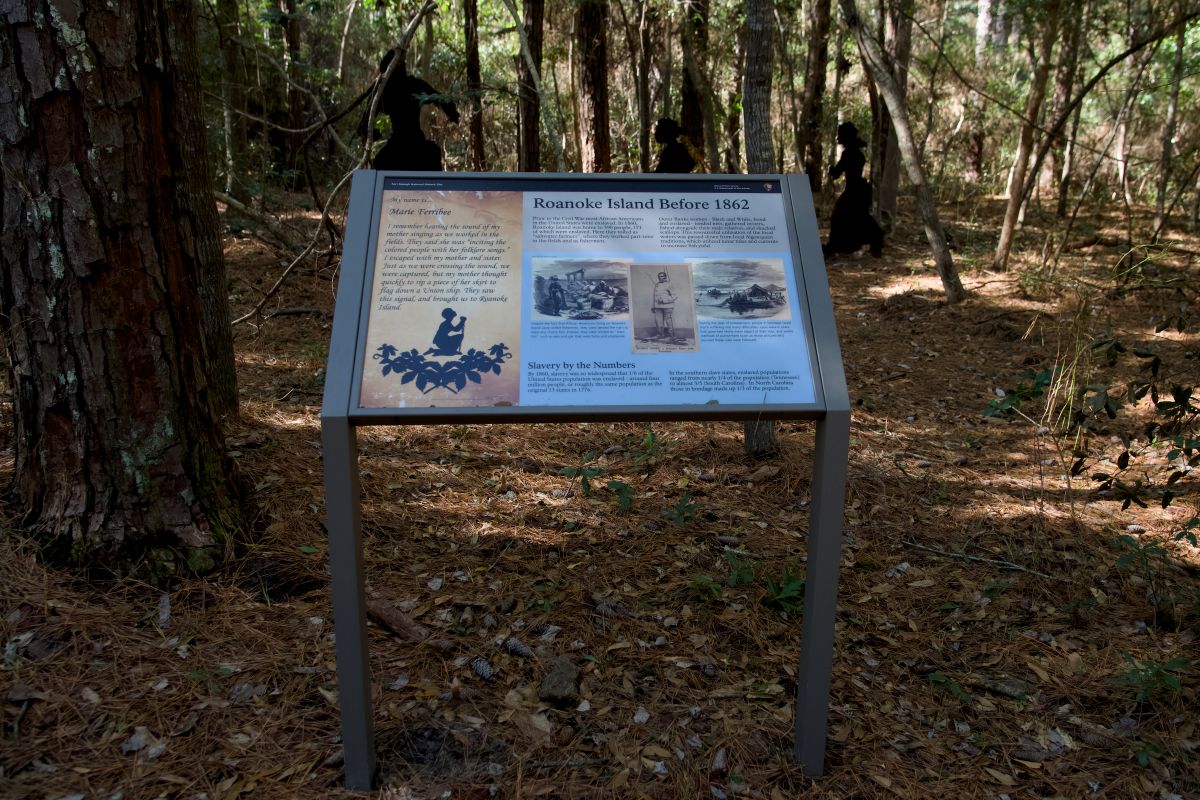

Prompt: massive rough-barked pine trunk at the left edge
[{"left": 0, "top": 0, "right": 242, "bottom": 578}]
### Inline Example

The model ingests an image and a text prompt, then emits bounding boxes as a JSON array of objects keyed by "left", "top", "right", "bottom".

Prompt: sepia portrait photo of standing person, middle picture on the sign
[{"left": 629, "top": 264, "right": 700, "bottom": 353}]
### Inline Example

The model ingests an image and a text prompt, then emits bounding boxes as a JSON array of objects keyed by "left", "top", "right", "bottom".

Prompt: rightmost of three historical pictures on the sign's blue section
[{"left": 689, "top": 258, "right": 791, "bottom": 320}]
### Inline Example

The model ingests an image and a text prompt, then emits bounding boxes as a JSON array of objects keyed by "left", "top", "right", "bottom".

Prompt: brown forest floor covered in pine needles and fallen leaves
[{"left": 0, "top": 199, "right": 1200, "bottom": 800}]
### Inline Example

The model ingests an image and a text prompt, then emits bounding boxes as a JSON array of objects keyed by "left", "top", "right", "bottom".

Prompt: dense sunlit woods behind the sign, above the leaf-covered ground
[{"left": 200, "top": 0, "right": 1200, "bottom": 233}]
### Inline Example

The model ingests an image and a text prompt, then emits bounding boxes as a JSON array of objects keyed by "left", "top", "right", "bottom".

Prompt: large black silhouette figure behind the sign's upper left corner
[{"left": 367, "top": 50, "right": 458, "bottom": 172}]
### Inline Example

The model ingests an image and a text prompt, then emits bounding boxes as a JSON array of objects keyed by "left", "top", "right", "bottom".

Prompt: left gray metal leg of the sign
[{"left": 320, "top": 417, "right": 376, "bottom": 792}]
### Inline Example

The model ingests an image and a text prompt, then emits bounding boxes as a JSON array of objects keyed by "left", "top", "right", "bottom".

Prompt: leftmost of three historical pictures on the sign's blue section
[{"left": 530, "top": 258, "right": 629, "bottom": 320}]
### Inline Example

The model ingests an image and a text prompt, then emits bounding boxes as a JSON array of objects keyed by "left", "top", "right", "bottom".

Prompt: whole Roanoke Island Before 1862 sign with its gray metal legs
[{"left": 322, "top": 172, "right": 850, "bottom": 789}]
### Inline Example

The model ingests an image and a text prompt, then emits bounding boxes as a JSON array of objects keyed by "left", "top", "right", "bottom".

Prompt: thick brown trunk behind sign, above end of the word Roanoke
[{"left": 576, "top": 0, "right": 612, "bottom": 173}]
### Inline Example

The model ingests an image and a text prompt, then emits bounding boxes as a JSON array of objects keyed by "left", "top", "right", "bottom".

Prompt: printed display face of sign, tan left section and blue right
[{"left": 353, "top": 175, "right": 821, "bottom": 410}]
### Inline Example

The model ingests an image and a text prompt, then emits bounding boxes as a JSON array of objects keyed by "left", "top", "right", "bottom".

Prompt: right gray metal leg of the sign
[{"left": 793, "top": 410, "right": 850, "bottom": 777}]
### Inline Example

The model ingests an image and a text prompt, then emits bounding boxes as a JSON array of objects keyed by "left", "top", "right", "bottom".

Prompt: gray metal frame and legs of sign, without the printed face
[{"left": 320, "top": 170, "right": 850, "bottom": 790}]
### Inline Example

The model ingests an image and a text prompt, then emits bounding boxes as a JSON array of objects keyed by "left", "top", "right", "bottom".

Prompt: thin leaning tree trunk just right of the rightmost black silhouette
[{"left": 839, "top": 0, "right": 966, "bottom": 303}]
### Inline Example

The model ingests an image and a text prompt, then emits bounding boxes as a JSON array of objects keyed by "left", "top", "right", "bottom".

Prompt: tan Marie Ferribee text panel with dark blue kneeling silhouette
[{"left": 359, "top": 188, "right": 522, "bottom": 408}]
